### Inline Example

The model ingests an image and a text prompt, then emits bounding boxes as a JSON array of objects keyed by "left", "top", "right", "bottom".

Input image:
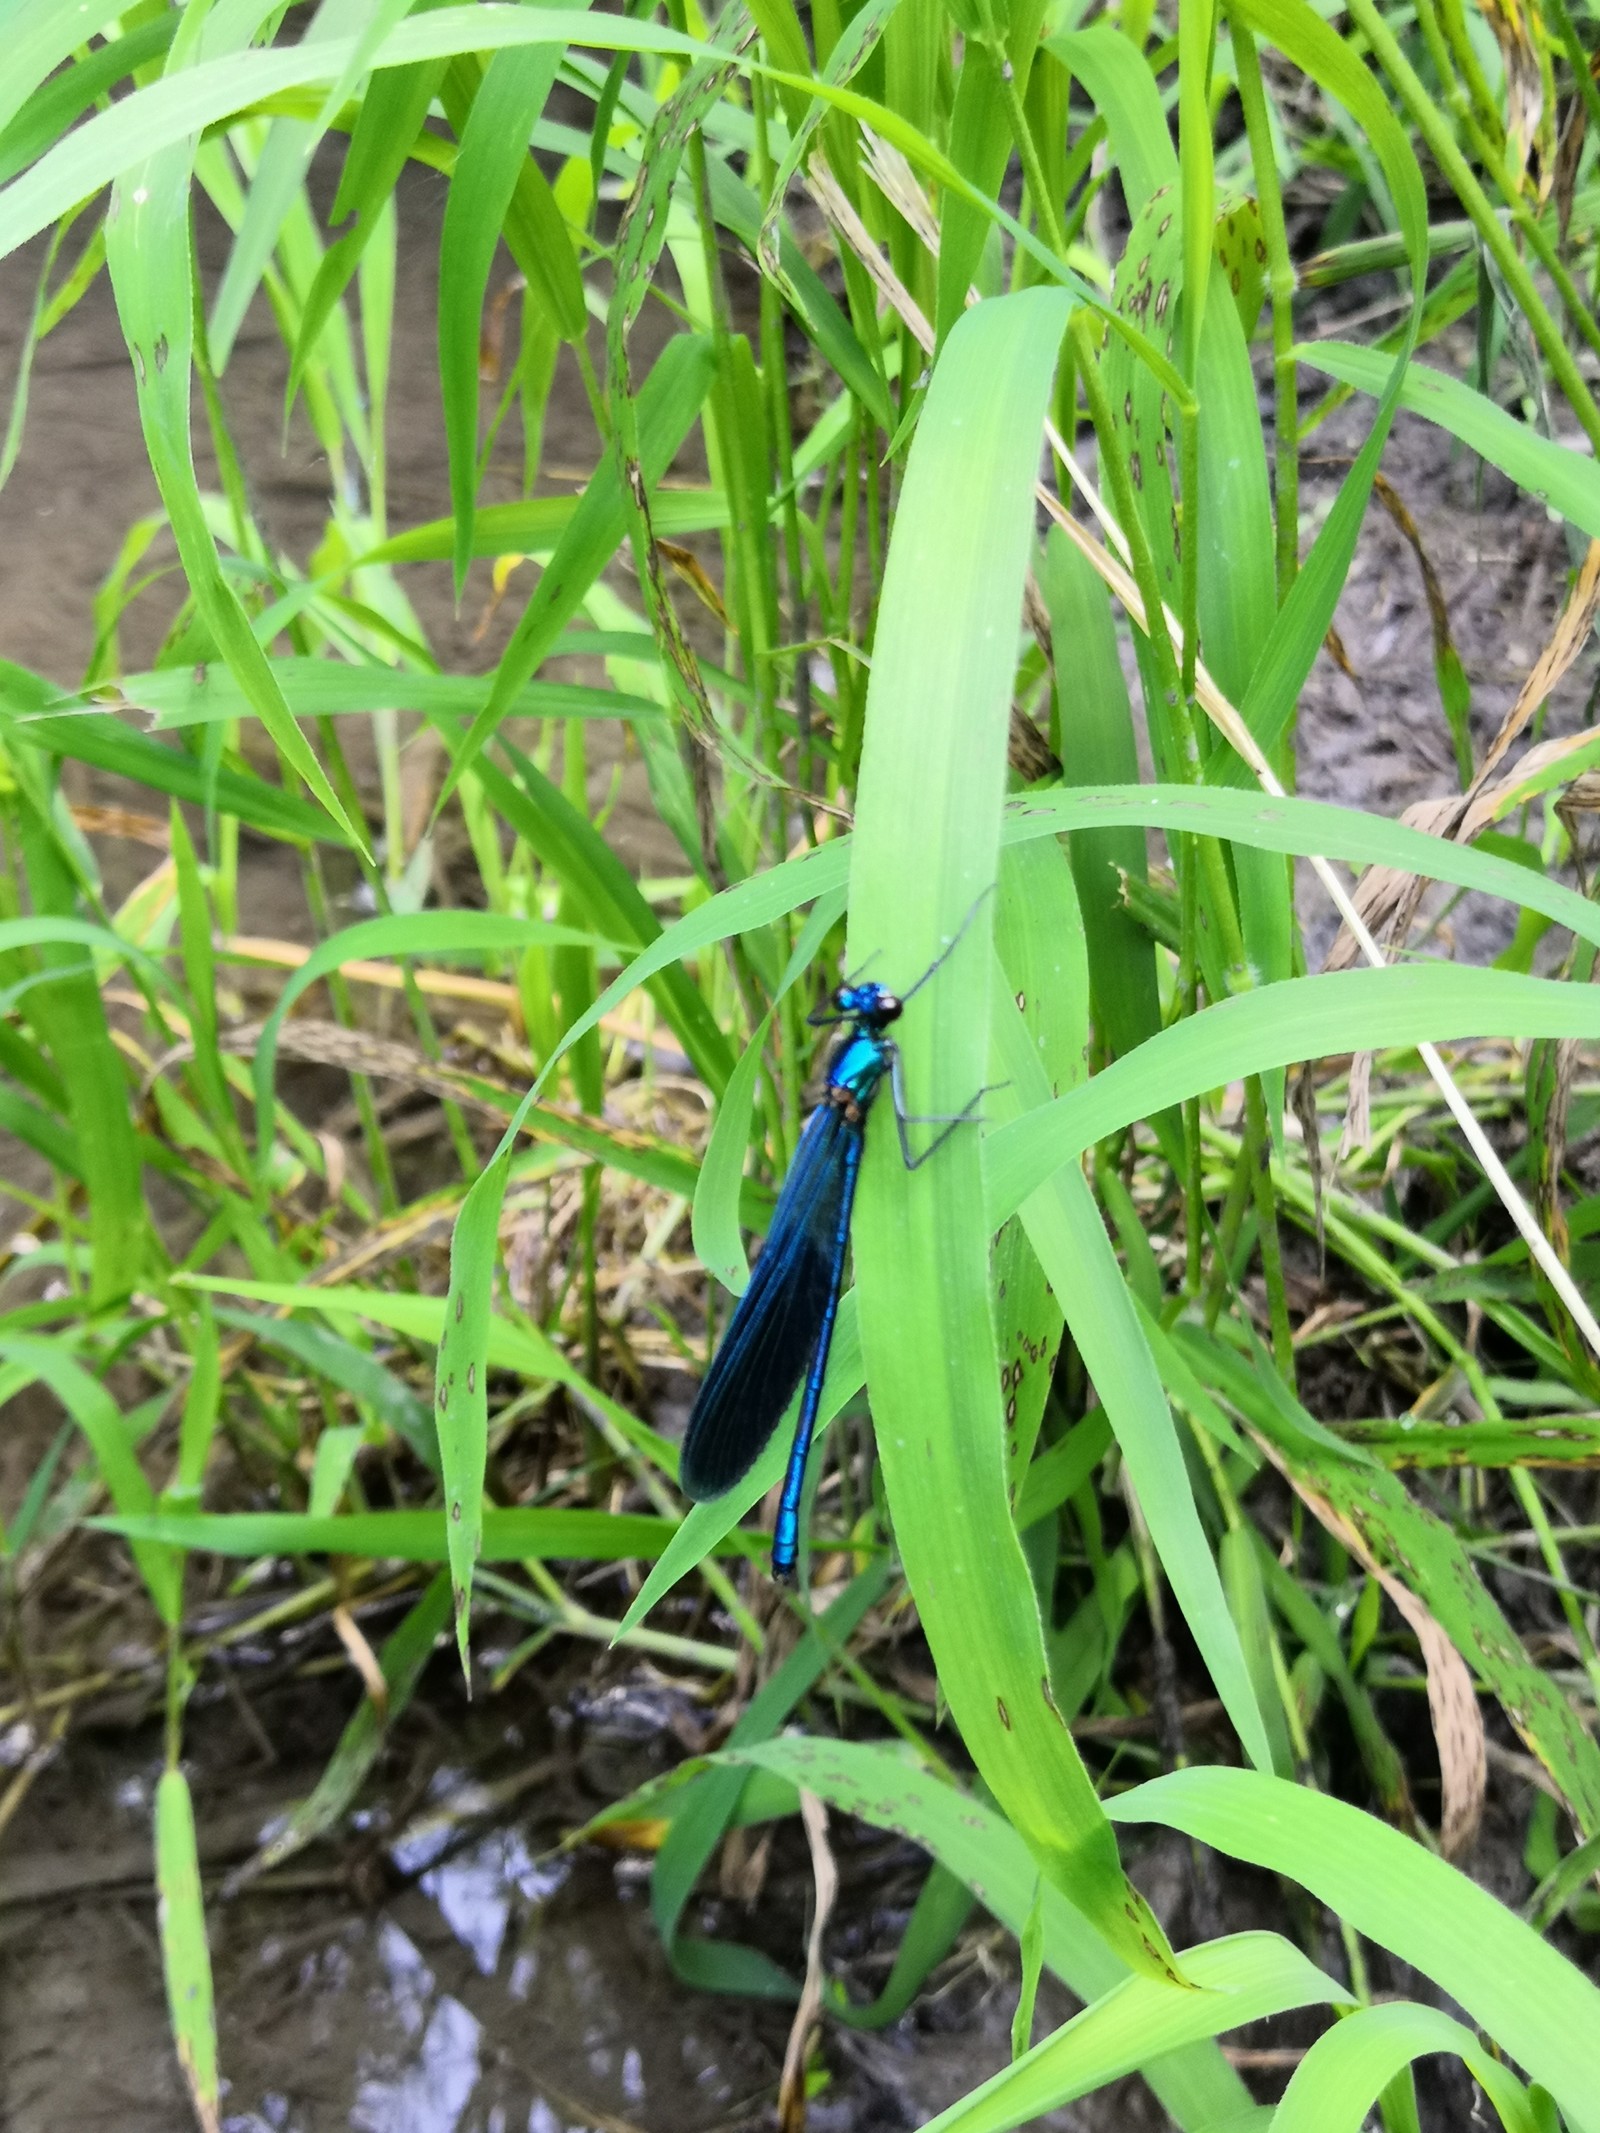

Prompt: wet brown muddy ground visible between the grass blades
[{"left": 0, "top": 154, "right": 1589, "bottom": 2133}]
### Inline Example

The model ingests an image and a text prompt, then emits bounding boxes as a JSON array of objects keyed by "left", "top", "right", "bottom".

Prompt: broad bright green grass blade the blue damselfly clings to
[{"left": 851, "top": 290, "right": 1173, "bottom": 1977}]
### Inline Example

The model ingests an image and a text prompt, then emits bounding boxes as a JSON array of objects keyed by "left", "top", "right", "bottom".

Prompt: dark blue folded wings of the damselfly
[{"left": 681, "top": 1103, "right": 862, "bottom": 1504}]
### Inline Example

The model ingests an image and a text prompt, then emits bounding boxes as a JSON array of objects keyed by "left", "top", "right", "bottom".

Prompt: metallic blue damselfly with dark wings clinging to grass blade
[{"left": 681, "top": 898, "right": 983, "bottom": 1578}]
